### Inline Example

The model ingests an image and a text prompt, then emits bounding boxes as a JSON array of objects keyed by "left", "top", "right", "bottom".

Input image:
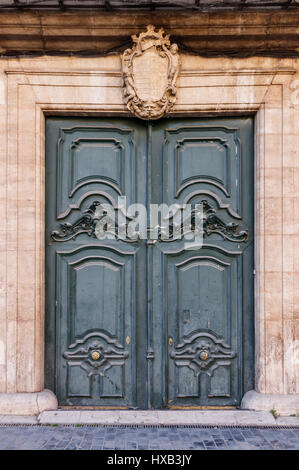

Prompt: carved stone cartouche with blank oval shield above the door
[{"left": 122, "top": 25, "right": 179, "bottom": 119}]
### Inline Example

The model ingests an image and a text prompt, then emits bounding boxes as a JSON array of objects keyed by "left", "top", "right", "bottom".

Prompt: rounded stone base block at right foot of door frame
[{"left": 241, "top": 390, "right": 299, "bottom": 416}]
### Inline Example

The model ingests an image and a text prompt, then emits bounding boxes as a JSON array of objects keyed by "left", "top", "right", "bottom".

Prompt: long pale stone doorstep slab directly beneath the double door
[{"left": 38, "top": 410, "right": 276, "bottom": 426}]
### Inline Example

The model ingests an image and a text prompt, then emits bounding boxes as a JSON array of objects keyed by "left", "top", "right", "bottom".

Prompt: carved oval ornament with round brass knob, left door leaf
[{"left": 63, "top": 332, "right": 129, "bottom": 374}]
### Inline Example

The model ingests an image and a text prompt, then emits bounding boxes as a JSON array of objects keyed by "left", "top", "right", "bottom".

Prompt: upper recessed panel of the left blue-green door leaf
[{"left": 56, "top": 124, "right": 135, "bottom": 219}]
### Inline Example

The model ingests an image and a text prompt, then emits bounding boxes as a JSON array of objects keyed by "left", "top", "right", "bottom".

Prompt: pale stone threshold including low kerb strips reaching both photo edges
[{"left": 0, "top": 410, "right": 299, "bottom": 427}]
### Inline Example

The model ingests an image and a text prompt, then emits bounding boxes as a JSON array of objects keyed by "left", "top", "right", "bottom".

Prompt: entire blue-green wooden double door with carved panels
[{"left": 45, "top": 117, "right": 254, "bottom": 409}]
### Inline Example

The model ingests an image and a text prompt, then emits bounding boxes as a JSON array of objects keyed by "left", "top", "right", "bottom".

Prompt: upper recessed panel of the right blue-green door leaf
[{"left": 164, "top": 125, "right": 242, "bottom": 217}]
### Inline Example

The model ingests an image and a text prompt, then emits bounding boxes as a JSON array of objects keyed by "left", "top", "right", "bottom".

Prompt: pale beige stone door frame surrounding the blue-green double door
[{"left": 0, "top": 63, "right": 298, "bottom": 414}]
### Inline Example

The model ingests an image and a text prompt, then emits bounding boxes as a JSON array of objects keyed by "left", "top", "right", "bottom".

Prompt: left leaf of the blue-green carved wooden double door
[{"left": 46, "top": 118, "right": 146, "bottom": 408}]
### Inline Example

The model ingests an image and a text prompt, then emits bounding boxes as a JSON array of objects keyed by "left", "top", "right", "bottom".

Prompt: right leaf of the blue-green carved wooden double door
[{"left": 151, "top": 118, "right": 253, "bottom": 407}]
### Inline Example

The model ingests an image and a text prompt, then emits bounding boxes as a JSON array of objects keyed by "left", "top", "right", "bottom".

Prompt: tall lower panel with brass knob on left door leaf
[{"left": 56, "top": 245, "right": 136, "bottom": 406}]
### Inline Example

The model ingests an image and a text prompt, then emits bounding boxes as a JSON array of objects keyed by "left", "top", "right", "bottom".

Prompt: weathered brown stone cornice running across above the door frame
[{"left": 0, "top": 10, "right": 299, "bottom": 57}]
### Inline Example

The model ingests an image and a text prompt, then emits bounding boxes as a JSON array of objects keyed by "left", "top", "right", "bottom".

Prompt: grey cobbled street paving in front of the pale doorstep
[{"left": 0, "top": 424, "right": 299, "bottom": 451}]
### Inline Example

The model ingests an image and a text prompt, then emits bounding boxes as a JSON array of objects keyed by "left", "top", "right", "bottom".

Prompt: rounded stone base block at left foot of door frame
[{"left": 0, "top": 389, "right": 58, "bottom": 416}]
